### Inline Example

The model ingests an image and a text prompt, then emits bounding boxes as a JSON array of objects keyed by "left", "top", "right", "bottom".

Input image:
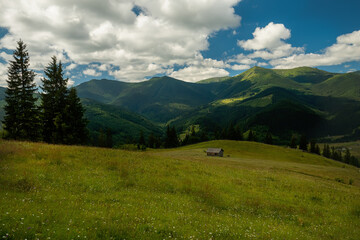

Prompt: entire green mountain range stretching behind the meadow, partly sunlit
[{"left": 0, "top": 67, "right": 360, "bottom": 142}]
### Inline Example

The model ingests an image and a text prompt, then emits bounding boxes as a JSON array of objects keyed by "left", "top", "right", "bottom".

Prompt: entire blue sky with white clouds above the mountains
[{"left": 0, "top": 0, "right": 360, "bottom": 86}]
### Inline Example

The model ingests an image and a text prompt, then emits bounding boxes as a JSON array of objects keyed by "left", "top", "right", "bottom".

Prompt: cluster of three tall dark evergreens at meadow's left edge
[{"left": 3, "top": 40, "right": 88, "bottom": 144}]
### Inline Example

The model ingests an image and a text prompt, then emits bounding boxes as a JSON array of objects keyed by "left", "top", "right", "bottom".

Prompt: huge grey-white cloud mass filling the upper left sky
[{"left": 0, "top": 0, "right": 241, "bottom": 81}]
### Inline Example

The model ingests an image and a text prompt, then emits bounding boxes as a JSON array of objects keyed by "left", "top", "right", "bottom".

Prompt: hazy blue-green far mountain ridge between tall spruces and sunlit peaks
[{"left": 77, "top": 77, "right": 215, "bottom": 123}]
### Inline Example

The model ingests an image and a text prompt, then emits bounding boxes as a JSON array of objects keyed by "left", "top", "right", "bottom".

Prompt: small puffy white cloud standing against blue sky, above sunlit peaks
[{"left": 238, "top": 22, "right": 303, "bottom": 60}]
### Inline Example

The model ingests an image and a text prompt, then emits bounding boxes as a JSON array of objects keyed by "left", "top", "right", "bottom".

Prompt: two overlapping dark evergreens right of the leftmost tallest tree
[{"left": 41, "top": 56, "right": 88, "bottom": 145}]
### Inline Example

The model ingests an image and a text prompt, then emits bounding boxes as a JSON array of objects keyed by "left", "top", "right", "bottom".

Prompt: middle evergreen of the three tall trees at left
[{"left": 41, "top": 56, "right": 68, "bottom": 143}]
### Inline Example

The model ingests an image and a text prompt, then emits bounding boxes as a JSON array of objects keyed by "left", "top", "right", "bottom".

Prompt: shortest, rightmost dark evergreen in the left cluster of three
[{"left": 62, "top": 88, "right": 88, "bottom": 144}]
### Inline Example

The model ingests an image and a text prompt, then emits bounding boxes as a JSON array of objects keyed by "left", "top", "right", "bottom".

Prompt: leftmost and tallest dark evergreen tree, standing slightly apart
[{"left": 3, "top": 40, "right": 40, "bottom": 141}]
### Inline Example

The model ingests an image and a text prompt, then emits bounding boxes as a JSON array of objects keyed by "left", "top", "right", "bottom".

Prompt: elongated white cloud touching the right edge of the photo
[{"left": 270, "top": 31, "right": 360, "bottom": 68}]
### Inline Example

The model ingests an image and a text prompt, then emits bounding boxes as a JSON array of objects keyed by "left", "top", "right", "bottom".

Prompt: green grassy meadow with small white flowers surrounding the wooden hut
[{"left": 0, "top": 141, "right": 360, "bottom": 239}]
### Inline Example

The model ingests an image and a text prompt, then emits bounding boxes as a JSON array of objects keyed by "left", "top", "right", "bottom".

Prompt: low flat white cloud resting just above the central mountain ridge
[{"left": 170, "top": 66, "right": 229, "bottom": 82}]
